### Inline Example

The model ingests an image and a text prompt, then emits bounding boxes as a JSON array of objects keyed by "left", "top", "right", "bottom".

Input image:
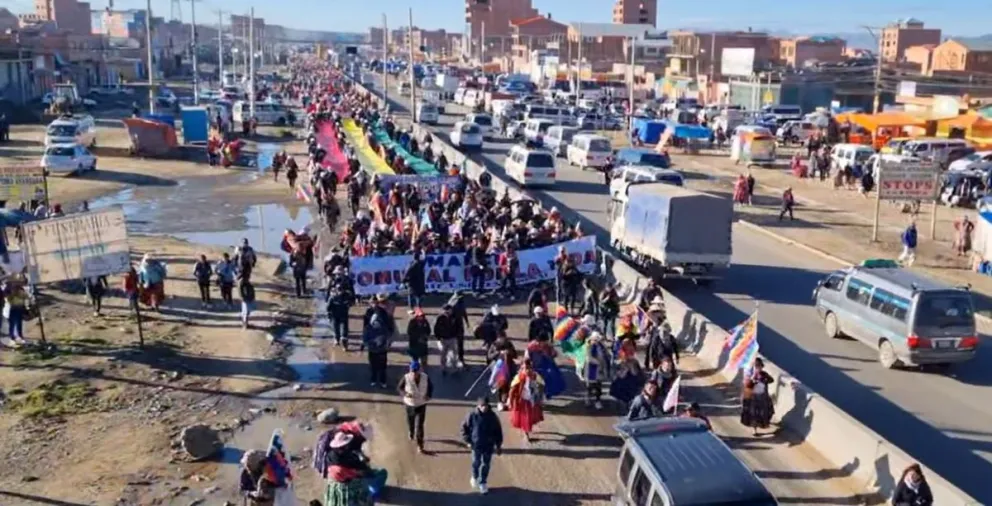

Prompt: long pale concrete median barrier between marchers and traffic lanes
[{"left": 344, "top": 73, "right": 981, "bottom": 506}]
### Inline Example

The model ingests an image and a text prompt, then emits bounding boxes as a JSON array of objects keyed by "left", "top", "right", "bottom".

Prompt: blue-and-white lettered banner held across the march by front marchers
[{"left": 351, "top": 236, "right": 596, "bottom": 295}]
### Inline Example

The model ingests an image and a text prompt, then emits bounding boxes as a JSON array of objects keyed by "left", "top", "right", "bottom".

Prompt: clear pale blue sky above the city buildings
[{"left": 0, "top": 0, "right": 992, "bottom": 35}]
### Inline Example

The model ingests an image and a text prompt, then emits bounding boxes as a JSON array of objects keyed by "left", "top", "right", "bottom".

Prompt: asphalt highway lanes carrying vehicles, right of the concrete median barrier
[{"left": 366, "top": 77, "right": 992, "bottom": 504}]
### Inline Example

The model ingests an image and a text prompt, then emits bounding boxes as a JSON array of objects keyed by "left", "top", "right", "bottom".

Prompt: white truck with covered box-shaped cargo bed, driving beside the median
[{"left": 609, "top": 183, "right": 734, "bottom": 284}]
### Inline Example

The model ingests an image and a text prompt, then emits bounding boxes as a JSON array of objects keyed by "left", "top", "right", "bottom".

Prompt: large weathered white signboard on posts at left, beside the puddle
[{"left": 23, "top": 207, "right": 131, "bottom": 283}]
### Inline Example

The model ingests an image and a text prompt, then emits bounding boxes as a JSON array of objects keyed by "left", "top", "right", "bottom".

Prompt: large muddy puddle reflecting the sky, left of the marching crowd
[{"left": 90, "top": 173, "right": 314, "bottom": 255}]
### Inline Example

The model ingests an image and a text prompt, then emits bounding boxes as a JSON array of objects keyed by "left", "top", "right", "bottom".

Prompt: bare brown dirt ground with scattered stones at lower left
[{"left": 0, "top": 236, "right": 299, "bottom": 505}]
